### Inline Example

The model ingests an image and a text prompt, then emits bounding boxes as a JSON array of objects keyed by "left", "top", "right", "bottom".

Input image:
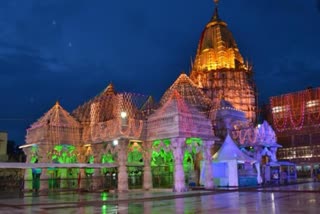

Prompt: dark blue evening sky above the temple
[{"left": 0, "top": 0, "right": 320, "bottom": 144}]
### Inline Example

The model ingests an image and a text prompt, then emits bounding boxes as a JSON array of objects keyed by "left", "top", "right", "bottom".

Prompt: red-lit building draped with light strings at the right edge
[{"left": 270, "top": 88, "right": 320, "bottom": 177}]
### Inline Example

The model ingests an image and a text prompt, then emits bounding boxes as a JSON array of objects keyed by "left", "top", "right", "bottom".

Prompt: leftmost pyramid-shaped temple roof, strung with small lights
[{"left": 30, "top": 102, "right": 80, "bottom": 129}]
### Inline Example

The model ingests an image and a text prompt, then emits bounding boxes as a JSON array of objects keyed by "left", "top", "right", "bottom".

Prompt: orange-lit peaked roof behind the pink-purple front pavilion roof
[{"left": 160, "top": 73, "right": 211, "bottom": 111}]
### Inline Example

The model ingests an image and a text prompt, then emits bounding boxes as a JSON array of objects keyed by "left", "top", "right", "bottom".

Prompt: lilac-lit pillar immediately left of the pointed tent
[{"left": 203, "top": 141, "right": 214, "bottom": 189}]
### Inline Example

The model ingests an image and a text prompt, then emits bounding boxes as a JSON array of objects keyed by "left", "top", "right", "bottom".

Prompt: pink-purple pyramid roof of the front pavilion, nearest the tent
[{"left": 147, "top": 90, "right": 216, "bottom": 140}]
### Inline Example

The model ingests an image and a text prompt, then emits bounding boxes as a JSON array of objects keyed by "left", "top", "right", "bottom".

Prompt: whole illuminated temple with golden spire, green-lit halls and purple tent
[{"left": 22, "top": 1, "right": 292, "bottom": 192}]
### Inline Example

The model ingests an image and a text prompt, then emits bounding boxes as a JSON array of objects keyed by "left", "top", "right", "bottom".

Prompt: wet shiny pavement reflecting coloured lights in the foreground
[{"left": 0, "top": 182, "right": 320, "bottom": 214}]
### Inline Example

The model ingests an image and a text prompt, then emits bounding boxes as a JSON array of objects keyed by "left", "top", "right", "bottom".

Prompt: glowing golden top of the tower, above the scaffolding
[{"left": 193, "top": 6, "right": 244, "bottom": 71}]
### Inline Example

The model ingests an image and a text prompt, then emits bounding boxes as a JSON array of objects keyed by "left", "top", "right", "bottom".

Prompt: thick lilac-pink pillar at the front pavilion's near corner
[{"left": 170, "top": 138, "right": 187, "bottom": 192}]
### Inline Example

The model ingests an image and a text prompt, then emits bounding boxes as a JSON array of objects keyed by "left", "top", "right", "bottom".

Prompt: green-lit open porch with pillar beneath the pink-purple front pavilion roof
[{"left": 151, "top": 138, "right": 210, "bottom": 191}]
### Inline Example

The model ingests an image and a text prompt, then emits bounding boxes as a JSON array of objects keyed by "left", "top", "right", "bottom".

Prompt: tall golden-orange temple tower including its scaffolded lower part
[{"left": 190, "top": 7, "right": 257, "bottom": 123}]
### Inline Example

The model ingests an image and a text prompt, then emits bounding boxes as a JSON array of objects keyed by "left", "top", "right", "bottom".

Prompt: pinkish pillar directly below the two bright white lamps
[{"left": 117, "top": 139, "right": 129, "bottom": 192}]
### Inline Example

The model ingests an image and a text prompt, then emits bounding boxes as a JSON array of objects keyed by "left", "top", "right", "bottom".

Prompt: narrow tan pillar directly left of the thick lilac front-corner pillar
[{"left": 143, "top": 141, "right": 153, "bottom": 190}]
